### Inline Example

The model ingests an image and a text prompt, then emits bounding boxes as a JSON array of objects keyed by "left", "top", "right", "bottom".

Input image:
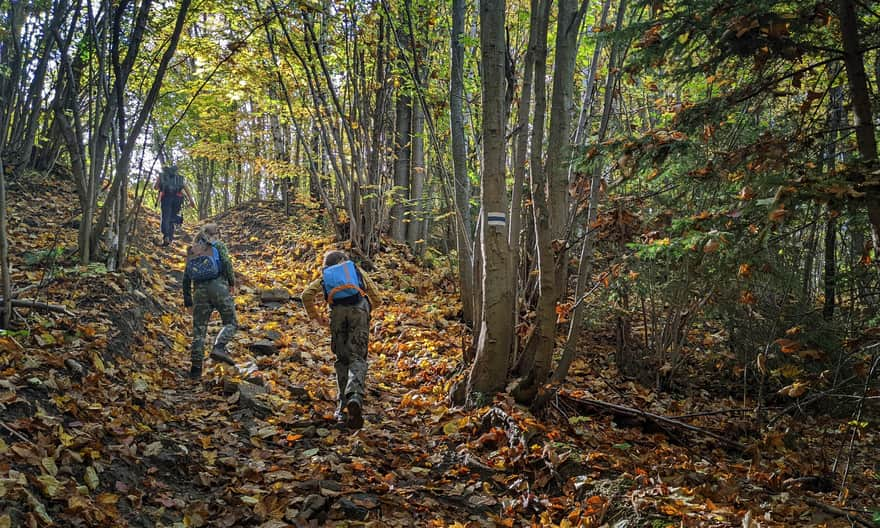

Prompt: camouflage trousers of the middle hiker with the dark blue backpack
[{"left": 190, "top": 277, "right": 238, "bottom": 365}]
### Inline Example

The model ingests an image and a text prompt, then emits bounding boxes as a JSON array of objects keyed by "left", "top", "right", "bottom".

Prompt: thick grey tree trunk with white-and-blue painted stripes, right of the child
[{"left": 467, "top": 0, "right": 514, "bottom": 405}]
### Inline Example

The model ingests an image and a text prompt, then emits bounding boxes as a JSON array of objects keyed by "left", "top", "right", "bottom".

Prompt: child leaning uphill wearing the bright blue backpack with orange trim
[{"left": 302, "top": 250, "right": 381, "bottom": 429}]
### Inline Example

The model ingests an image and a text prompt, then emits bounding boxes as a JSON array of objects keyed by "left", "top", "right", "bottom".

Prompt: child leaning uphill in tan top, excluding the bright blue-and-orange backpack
[{"left": 302, "top": 251, "right": 381, "bottom": 429}]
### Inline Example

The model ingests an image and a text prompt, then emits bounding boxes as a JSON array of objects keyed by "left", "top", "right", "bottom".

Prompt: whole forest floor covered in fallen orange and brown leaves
[{"left": 0, "top": 171, "right": 880, "bottom": 528}]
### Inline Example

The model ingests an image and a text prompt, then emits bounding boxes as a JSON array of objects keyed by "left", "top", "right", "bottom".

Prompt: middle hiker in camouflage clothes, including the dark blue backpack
[{"left": 183, "top": 223, "right": 238, "bottom": 380}]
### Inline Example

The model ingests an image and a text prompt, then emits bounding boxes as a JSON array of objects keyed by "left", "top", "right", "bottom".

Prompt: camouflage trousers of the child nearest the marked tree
[{"left": 330, "top": 300, "right": 370, "bottom": 407}]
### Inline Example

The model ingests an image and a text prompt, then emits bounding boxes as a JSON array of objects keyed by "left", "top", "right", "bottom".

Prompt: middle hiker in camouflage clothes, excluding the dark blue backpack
[{"left": 183, "top": 224, "right": 238, "bottom": 379}]
